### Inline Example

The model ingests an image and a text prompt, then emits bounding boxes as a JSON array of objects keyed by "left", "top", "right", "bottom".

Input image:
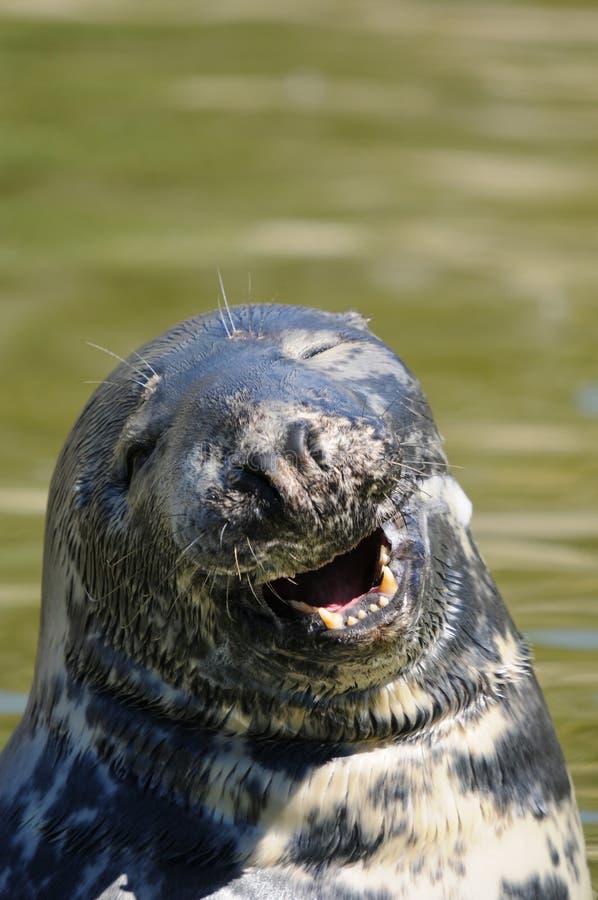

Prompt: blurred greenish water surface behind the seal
[{"left": 0, "top": 0, "right": 598, "bottom": 883}]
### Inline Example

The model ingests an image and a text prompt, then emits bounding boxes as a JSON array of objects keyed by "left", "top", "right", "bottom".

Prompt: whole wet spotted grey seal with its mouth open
[{"left": 0, "top": 305, "right": 590, "bottom": 900}]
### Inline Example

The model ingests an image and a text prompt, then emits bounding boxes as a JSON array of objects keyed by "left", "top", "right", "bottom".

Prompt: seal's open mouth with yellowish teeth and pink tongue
[{"left": 262, "top": 528, "right": 398, "bottom": 629}]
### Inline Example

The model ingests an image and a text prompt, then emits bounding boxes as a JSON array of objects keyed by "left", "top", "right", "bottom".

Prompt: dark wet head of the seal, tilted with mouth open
[{"left": 43, "top": 306, "right": 454, "bottom": 739}]
